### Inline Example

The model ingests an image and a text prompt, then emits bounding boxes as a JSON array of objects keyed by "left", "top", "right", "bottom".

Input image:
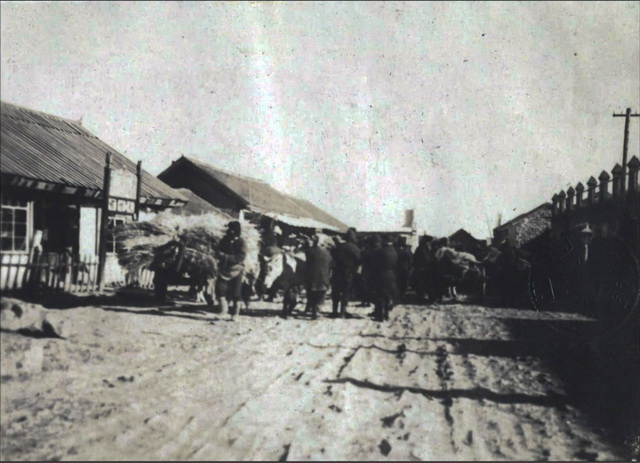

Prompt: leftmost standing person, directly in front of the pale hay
[{"left": 216, "top": 220, "right": 247, "bottom": 316}]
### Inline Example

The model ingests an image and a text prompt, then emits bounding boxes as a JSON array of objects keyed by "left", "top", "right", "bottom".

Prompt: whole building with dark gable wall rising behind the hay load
[{"left": 158, "top": 156, "right": 348, "bottom": 234}]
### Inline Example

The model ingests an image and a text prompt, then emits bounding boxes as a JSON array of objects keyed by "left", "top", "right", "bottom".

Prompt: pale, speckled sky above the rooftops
[{"left": 0, "top": 2, "right": 640, "bottom": 238}]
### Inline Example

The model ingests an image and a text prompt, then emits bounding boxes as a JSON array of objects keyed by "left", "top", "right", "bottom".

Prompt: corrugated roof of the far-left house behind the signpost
[{"left": 0, "top": 101, "right": 186, "bottom": 201}]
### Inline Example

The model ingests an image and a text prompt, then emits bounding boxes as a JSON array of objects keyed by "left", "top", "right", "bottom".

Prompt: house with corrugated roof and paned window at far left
[{"left": 0, "top": 102, "right": 187, "bottom": 289}]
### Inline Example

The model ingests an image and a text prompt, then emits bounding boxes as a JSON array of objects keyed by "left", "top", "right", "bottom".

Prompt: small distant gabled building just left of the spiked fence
[{"left": 493, "top": 203, "right": 553, "bottom": 248}]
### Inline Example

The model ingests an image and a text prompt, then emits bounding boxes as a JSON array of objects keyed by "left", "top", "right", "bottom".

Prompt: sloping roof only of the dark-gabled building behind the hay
[{"left": 159, "top": 156, "right": 348, "bottom": 231}]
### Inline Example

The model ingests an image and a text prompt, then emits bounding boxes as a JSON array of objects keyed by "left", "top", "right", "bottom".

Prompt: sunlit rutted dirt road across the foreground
[{"left": 0, "top": 296, "right": 632, "bottom": 460}]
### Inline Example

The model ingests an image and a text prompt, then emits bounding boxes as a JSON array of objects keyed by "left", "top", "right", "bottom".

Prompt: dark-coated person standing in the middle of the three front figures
[{"left": 331, "top": 228, "right": 360, "bottom": 318}]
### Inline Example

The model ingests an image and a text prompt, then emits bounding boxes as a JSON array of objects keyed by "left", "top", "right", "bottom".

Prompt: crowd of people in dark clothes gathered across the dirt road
[{"left": 210, "top": 221, "right": 484, "bottom": 321}]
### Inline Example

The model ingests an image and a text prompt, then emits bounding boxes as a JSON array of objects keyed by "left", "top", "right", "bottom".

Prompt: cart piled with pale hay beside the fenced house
[{"left": 114, "top": 211, "right": 260, "bottom": 305}]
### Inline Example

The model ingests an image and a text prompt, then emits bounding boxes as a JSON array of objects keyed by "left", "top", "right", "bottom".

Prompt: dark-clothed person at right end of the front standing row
[{"left": 372, "top": 235, "right": 398, "bottom": 322}]
